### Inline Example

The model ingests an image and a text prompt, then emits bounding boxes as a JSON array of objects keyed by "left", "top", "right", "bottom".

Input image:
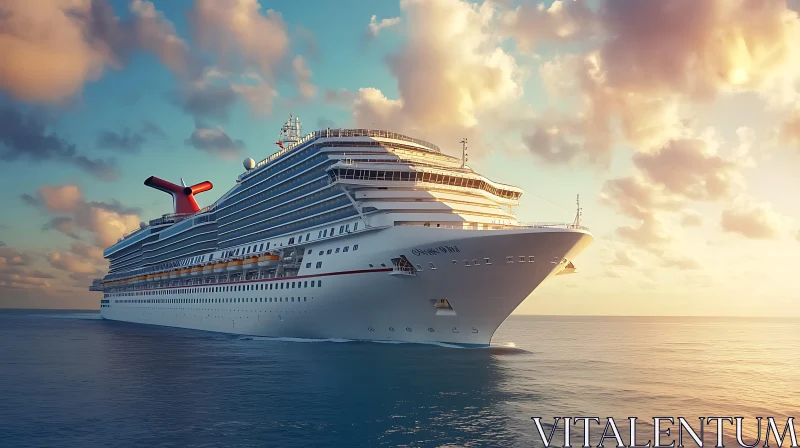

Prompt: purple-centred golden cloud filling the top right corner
[{"left": 598, "top": 0, "right": 800, "bottom": 99}]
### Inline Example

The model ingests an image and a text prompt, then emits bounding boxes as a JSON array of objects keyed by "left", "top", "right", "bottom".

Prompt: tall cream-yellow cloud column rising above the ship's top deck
[{"left": 352, "top": 0, "right": 522, "bottom": 154}]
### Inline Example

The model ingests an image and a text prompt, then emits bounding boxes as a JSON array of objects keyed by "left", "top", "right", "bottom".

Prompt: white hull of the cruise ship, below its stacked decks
[{"left": 101, "top": 226, "right": 593, "bottom": 346}]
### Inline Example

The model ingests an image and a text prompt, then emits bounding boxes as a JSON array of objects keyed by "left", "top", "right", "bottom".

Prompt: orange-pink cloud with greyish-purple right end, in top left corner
[{"left": 0, "top": 0, "right": 187, "bottom": 103}]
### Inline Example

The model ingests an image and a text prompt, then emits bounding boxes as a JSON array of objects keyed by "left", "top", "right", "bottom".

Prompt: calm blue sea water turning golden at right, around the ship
[{"left": 0, "top": 310, "right": 800, "bottom": 447}]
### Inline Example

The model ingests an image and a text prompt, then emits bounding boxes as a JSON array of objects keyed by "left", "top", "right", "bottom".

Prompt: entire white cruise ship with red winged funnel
[{"left": 90, "top": 116, "right": 594, "bottom": 346}]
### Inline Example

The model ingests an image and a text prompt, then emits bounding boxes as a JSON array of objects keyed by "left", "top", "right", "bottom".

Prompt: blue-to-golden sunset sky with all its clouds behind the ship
[{"left": 0, "top": 0, "right": 800, "bottom": 317}]
